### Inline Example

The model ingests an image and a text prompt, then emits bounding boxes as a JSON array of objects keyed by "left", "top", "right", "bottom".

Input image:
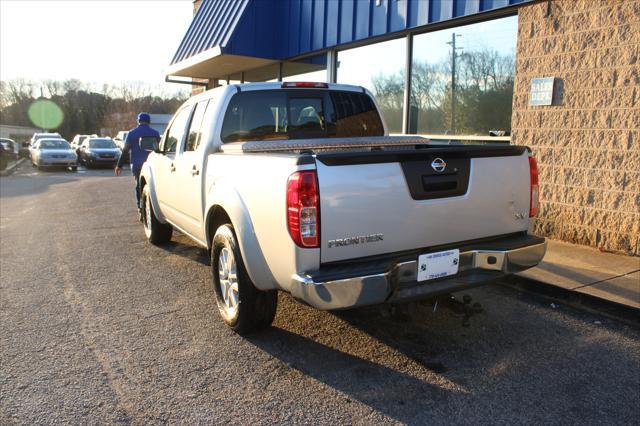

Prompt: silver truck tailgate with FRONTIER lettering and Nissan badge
[{"left": 316, "top": 146, "right": 530, "bottom": 263}]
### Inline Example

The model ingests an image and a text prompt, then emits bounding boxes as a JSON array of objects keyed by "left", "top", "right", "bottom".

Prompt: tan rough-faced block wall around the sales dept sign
[{"left": 512, "top": 0, "right": 640, "bottom": 255}]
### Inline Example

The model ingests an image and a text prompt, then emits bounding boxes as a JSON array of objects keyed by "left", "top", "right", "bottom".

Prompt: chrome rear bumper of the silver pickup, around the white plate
[{"left": 290, "top": 241, "right": 547, "bottom": 310}]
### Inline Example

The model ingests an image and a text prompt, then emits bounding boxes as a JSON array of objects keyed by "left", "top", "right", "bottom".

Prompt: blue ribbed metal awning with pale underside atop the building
[{"left": 169, "top": 0, "right": 535, "bottom": 78}]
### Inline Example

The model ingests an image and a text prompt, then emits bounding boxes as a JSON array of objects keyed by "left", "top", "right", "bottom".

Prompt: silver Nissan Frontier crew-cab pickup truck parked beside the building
[{"left": 141, "top": 83, "right": 546, "bottom": 334}]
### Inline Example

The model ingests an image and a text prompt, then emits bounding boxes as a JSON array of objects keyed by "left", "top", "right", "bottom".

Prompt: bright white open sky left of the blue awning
[{"left": 0, "top": 0, "right": 193, "bottom": 92}]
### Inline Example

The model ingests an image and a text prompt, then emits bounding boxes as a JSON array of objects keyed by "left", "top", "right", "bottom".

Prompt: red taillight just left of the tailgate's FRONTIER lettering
[{"left": 287, "top": 170, "right": 320, "bottom": 248}]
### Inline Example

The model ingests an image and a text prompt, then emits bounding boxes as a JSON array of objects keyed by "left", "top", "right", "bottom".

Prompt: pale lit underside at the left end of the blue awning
[{"left": 165, "top": 47, "right": 277, "bottom": 79}]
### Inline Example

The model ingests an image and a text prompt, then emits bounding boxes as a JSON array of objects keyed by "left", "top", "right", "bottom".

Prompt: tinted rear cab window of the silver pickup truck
[{"left": 221, "top": 89, "right": 384, "bottom": 143}]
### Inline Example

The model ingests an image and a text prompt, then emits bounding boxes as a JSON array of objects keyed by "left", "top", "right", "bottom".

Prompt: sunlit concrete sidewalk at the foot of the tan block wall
[{"left": 518, "top": 239, "right": 640, "bottom": 309}]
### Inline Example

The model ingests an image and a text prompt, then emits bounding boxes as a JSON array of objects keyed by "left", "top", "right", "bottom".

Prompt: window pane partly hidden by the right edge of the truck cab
[{"left": 337, "top": 38, "right": 406, "bottom": 133}]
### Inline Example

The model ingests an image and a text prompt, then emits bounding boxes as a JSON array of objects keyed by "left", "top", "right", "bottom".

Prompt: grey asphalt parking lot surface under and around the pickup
[{"left": 0, "top": 164, "right": 640, "bottom": 424}]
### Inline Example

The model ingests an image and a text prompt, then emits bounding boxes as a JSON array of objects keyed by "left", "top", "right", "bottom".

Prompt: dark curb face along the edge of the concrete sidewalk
[{"left": 500, "top": 275, "right": 640, "bottom": 328}]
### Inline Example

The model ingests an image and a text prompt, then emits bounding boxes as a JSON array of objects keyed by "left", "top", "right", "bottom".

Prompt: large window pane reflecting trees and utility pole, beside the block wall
[{"left": 408, "top": 16, "right": 518, "bottom": 135}]
